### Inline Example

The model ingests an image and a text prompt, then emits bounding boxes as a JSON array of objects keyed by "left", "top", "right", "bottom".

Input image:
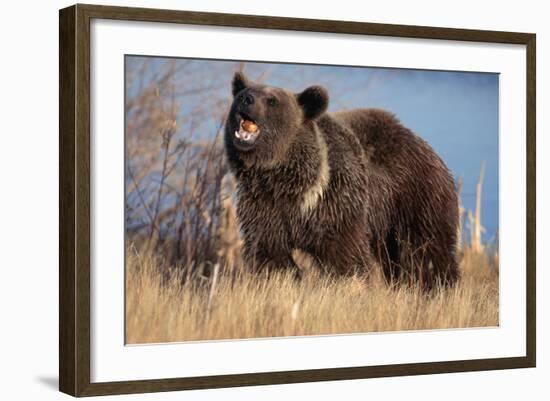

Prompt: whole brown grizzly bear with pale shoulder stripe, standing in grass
[{"left": 225, "top": 72, "right": 459, "bottom": 289}]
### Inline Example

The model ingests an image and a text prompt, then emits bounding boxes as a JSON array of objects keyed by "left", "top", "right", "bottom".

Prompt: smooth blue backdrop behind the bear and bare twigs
[{"left": 127, "top": 56, "right": 499, "bottom": 240}]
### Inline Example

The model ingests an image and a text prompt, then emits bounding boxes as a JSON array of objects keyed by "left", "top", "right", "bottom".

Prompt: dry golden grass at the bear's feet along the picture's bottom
[{"left": 126, "top": 244, "right": 499, "bottom": 344}]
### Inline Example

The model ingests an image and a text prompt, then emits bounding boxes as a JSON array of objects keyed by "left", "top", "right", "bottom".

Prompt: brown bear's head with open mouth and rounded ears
[{"left": 225, "top": 72, "right": 328, "bottom": 167}]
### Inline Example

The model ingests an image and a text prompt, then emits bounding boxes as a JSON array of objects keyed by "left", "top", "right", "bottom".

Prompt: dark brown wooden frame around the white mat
[{"left": 59, "top": 4, "right": 536, "bottom": 396}]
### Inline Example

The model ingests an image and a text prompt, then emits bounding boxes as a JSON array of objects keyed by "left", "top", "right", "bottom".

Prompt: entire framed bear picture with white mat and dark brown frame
[{"left": 59, "top": 5, "right": 536, "bottom": 396}]
